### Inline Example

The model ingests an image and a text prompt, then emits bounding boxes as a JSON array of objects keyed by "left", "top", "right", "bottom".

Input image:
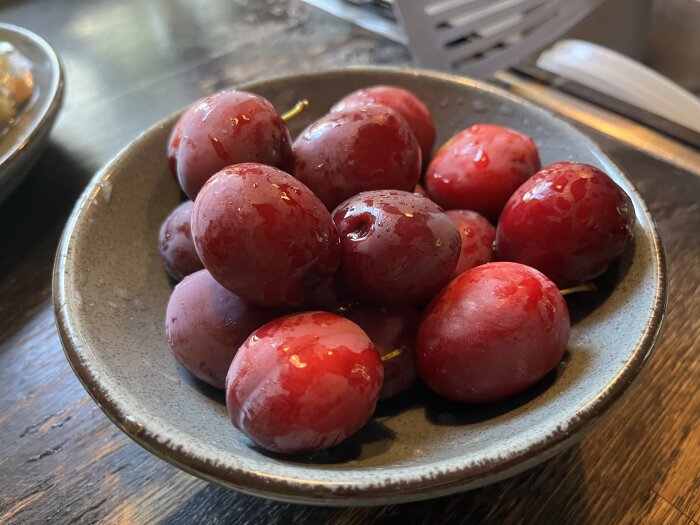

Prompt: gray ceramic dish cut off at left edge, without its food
[{"left": 0, "top": 24, "right": 63, "bottom": 203}]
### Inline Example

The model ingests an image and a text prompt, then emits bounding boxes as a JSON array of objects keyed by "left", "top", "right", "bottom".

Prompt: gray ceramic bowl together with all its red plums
[{"left": 54, "top": 67, "right": 667, "bottom": 505}]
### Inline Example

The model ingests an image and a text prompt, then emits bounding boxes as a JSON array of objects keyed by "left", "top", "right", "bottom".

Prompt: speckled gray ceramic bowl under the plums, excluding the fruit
[{"left": 54, "top": 68, "right": 666, "bottom": 505}]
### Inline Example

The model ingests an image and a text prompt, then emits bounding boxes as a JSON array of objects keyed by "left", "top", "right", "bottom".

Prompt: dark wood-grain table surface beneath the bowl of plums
[{"left": 0, "top": 0, "right": 700, "bottom": 524}]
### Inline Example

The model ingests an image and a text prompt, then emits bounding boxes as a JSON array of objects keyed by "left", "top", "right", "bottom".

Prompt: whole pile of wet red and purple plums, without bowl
[{"left": 159, "top": 86, "right": 635, "bottom": 454}]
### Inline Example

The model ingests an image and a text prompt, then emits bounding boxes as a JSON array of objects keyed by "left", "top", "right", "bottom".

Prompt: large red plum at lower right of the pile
[{"left": 416, "top": 262, "right": 570, "bottom": 403}]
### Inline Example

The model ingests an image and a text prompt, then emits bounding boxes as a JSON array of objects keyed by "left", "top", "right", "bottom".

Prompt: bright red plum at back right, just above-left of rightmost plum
[{"left": 425, "top": 124, "right": 540, "bottom": 222}]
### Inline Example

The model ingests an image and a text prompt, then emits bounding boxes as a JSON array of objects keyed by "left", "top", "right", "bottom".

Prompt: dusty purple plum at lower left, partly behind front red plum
[{"left": 165, "top": 270, "right": 276, "bottom": 389}]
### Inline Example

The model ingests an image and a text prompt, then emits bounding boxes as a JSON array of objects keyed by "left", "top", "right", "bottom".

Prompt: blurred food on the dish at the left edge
[{"left": 0, "top": 42, "right": 34, "bottom": 131}]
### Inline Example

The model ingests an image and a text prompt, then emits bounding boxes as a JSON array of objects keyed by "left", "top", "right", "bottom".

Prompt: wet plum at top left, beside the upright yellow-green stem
[{"left": 176, "top": 90, "right": 293, "bottom": 200}]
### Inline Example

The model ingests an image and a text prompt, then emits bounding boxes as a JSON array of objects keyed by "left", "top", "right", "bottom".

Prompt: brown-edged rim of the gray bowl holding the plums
[{"left": 52, "top": 66, "right": 668, "bottom": 505}]
